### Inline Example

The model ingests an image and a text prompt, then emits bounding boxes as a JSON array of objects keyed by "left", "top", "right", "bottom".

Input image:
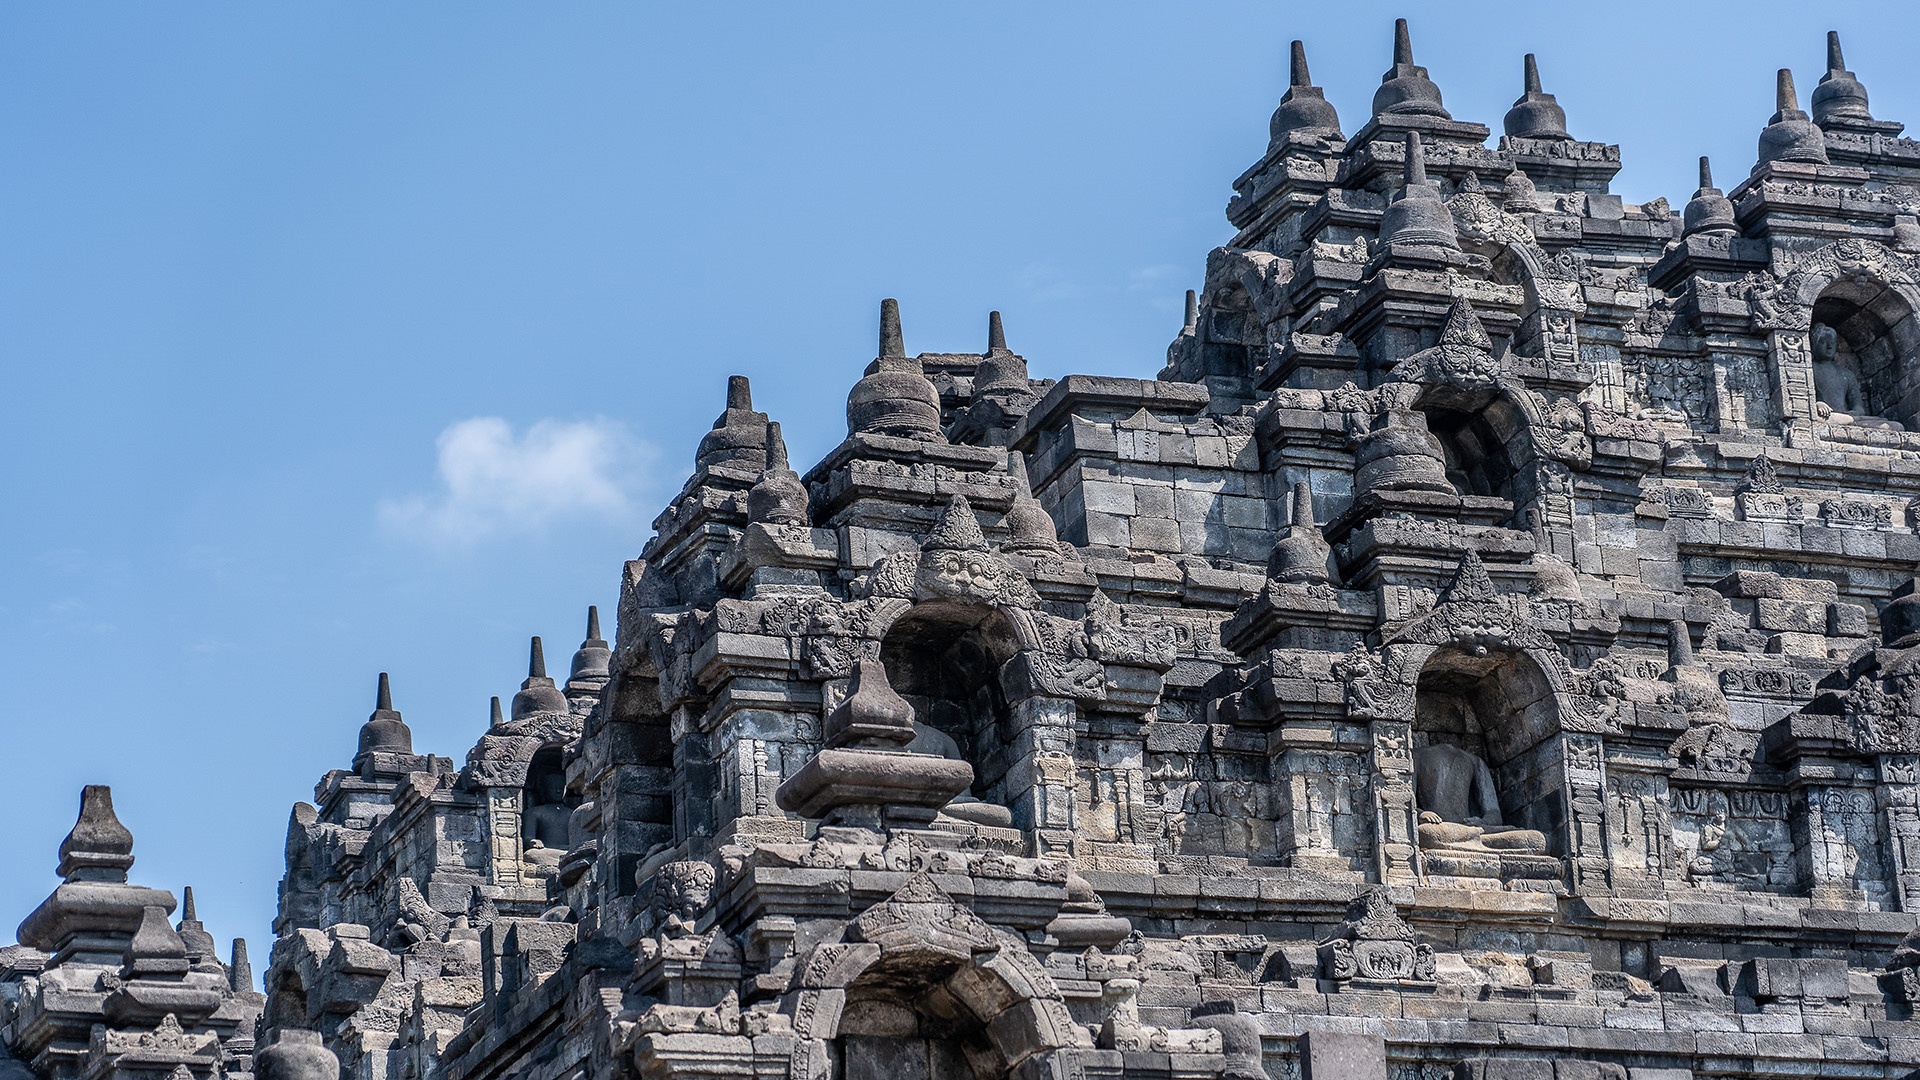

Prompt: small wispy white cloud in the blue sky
[{"left": 380, "top": 417, "right": 651, "bottom": 544}]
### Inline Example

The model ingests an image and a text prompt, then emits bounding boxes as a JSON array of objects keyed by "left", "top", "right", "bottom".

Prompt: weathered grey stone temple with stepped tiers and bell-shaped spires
[{"left": 18, "top": 14, "right": 1920, "bottom": 1080}]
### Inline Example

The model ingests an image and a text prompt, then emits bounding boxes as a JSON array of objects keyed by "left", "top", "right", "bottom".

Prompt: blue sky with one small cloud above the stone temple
[{"left": 0, "top": 2, "right": 1920, "bottom": 965}]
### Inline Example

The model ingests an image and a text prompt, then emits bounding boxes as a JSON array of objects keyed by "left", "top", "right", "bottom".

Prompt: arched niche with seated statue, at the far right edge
[{"left": 1809, "top": 277, "right": 1920, "bottom": 427}]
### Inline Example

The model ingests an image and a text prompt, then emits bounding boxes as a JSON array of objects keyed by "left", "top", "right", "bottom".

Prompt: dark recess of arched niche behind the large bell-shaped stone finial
[{"left": 879, "top": 600, "right": 1020, "bottom": 807}]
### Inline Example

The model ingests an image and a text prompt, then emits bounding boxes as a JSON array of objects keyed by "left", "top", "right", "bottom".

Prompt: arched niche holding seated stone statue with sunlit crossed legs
[{"left": 1413, "top": 648, "right": 1565, "bottom": 878}]
